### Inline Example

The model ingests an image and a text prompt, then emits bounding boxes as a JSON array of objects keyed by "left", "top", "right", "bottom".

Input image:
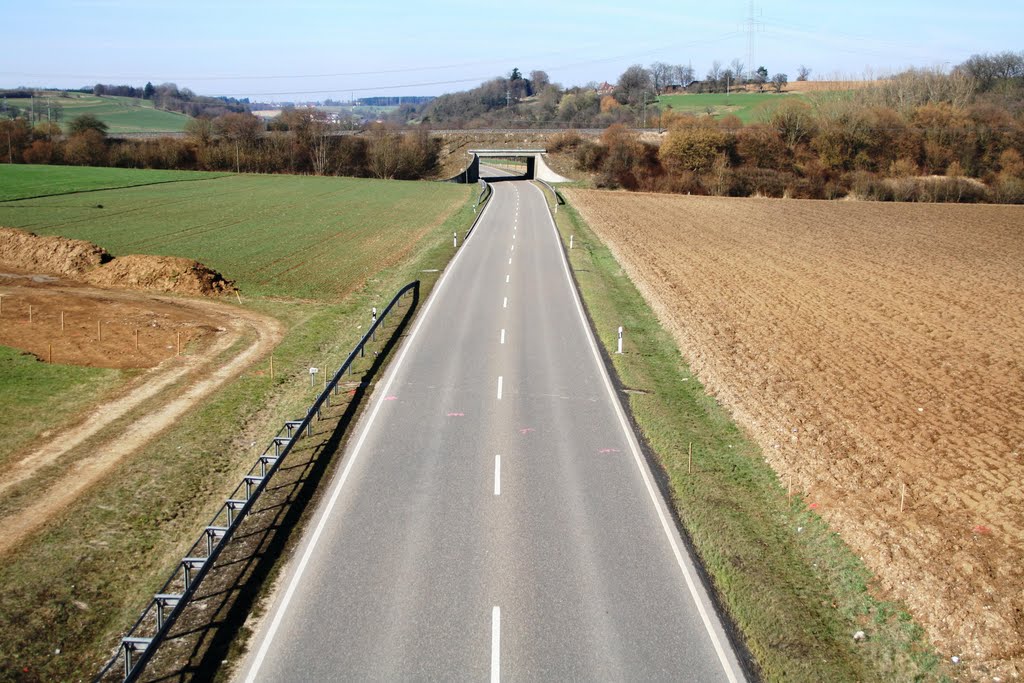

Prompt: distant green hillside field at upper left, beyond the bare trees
[{"left": 24, "top": 91, "right": 189, "bottom": 135}]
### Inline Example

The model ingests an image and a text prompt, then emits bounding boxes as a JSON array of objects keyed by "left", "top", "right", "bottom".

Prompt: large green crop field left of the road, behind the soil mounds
[{"left": 0, "top": 166, "right": 469, "bottom": 300}]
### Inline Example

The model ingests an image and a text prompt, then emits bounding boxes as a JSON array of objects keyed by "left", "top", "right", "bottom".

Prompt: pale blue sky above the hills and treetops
[{"left": 0, "top": 0, "right": 1024, "bottom": 100}]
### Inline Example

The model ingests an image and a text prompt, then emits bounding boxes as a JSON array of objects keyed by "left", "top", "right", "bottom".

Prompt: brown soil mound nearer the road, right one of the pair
[{"left": 83, "top": 254, "right": 234, "bottom": 296}]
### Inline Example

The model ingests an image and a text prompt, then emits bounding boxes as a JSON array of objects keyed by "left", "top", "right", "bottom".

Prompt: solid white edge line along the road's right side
[{"left": 531, "top": 185, "right": 739, "bottom": 683}]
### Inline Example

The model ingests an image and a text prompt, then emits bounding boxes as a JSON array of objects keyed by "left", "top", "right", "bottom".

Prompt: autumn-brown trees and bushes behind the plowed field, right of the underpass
[{"left": 561, "top": 62, "right": 1024, "bottom": 204}]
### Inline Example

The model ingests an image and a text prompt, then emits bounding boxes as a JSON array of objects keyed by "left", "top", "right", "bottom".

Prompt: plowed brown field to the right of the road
[{"left": 566, "top": 190, "right": 1024, "bottom": 672}]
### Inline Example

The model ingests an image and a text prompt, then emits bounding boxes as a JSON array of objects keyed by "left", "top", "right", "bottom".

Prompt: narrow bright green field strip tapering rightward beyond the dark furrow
[{"left": 0, "top": 164, "right": 226, "bottom": 202}]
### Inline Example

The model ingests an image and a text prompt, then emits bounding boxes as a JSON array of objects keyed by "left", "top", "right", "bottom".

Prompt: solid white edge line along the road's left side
[{"left": 245, "top": 184, "right": 494, "bottom": 683}]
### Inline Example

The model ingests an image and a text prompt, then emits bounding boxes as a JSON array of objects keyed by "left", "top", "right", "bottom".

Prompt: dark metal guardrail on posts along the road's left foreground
[{"left": 94, "top": 280, "right": 420, "bottom": 683}]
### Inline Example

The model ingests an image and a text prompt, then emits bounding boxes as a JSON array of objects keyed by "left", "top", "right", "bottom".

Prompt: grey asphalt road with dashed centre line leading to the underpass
[{"left": 240, "top": 171, "right": 743, "bottom": 681}]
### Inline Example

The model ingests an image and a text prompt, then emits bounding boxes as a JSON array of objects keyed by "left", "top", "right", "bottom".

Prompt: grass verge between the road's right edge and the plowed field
[{"left": 544, "top": 187, "right": 943, "bottom": 681}]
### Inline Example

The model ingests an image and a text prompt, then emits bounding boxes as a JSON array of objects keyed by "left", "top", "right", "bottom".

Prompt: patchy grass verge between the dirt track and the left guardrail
[{"left": 0, "top": 188, "right": 473, "bottom": 681}]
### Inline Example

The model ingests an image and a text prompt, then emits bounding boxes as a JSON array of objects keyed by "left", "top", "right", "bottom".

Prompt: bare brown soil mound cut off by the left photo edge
[{"left": 0, "top": 227, "right": 113, "bottom": 275}]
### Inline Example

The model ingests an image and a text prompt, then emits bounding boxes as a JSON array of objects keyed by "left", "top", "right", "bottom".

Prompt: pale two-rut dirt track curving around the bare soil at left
[{"left": 0, "top": 290, "right": 284, "bottom": 554}]
